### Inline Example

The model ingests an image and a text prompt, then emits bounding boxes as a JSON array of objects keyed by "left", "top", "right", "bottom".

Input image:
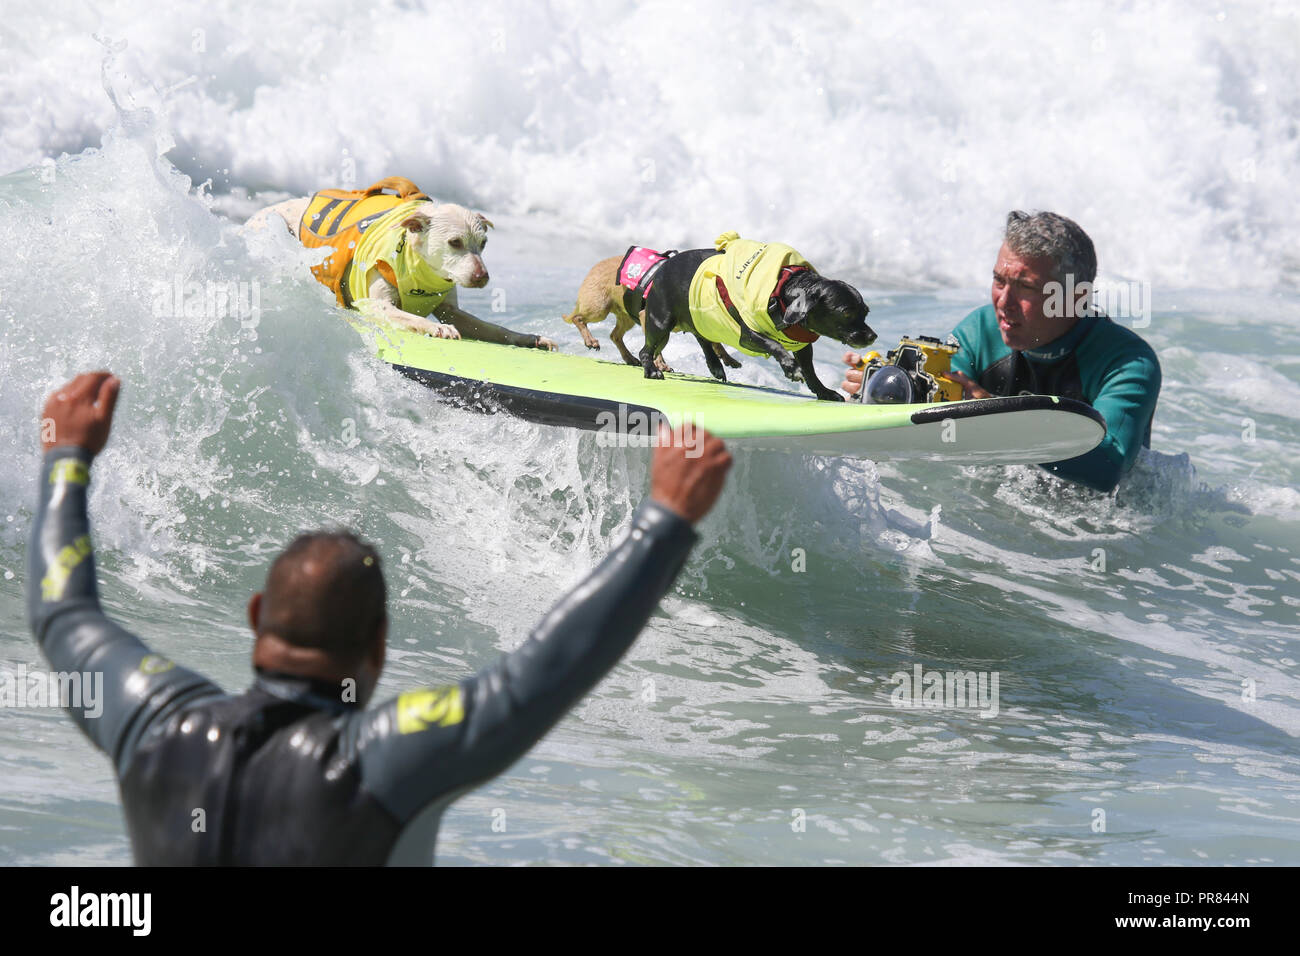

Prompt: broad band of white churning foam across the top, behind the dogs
[{"left": 0, "top": 0, "right": 1300, "bottom": 291}]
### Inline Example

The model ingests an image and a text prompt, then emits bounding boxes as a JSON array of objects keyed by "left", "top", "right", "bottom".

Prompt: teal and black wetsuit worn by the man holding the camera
[{"left": 953, "top": 303, "right": 1160, "bottom": 492}]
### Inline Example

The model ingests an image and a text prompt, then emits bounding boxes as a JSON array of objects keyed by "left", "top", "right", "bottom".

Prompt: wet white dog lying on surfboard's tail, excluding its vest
[{"left": 246, "top": 178, "right": 556, "bottom": 351}]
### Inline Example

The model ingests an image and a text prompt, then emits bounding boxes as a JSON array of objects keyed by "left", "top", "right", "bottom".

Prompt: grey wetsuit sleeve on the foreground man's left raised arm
[{"left": 27, "top": 447, "right": 221, "bottom": 774}]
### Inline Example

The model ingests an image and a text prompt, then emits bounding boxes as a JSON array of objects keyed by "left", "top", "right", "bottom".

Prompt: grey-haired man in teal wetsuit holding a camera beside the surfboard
[{"left": 841, "top": 211, "right": 1161, "bottom": 492}]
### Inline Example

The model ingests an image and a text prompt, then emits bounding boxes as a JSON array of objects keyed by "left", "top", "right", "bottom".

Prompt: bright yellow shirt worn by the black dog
[{"left": 689, "top": 233, "right": 813, "bottom": 355}]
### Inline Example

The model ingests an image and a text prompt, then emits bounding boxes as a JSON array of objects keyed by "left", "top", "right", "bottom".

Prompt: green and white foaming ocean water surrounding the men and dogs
[{"left": 0, "top": 0, "right": 1300, "bottom": 865}]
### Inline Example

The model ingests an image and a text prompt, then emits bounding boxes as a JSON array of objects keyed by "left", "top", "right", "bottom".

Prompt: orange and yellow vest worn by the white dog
[{"left": 298, "top": 177, "right": 455, "bottom": 316}]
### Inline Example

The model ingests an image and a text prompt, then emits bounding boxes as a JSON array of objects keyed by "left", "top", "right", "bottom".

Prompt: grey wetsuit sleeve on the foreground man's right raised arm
[{"left": 359, "top": 499, "right": 696, "bottom": 823}]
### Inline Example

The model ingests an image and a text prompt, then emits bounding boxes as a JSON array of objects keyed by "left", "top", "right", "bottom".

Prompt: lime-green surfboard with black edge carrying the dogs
[{"left": 348, "top": 316, "right": 1106, "bottom": 464}]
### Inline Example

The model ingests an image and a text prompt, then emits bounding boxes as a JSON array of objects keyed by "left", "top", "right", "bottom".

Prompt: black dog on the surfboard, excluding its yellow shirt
[{"left": 638, "top": 248, "right": 876, "bottom": 402}]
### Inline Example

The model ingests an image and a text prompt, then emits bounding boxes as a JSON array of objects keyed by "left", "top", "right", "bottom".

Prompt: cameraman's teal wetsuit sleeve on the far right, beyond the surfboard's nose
[{"left": 1043, "top": 354, "right": 1161, "bottom": 492}]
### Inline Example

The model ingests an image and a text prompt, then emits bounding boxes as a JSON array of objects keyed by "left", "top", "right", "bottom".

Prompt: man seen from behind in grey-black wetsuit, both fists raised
[{"left": 27, "top": 372, "right": 731, "bottom": 865}]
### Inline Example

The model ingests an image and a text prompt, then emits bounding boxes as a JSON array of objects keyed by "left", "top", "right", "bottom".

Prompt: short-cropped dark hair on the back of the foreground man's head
[{"left": 257, "top": 531, "right": 387, "bottom": 663}]
